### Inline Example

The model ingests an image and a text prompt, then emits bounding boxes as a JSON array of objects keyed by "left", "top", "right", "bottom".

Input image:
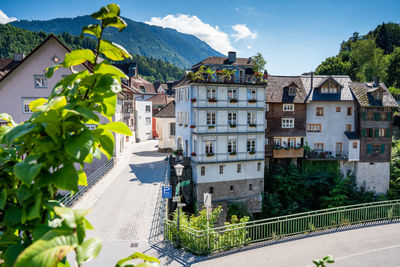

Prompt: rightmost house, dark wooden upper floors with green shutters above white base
[{"left": 350, "top": 78, "right": 398, "bottom": 193}]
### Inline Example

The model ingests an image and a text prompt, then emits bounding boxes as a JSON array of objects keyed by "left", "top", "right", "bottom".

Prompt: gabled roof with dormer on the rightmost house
[{"left": 350, "top": 82, "right": 398, "bottom": 107}]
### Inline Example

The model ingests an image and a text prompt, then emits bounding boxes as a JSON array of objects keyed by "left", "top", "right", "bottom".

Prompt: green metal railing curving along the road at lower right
[{"left": 164, "top": 200, "right": 400, "bottom": 255}]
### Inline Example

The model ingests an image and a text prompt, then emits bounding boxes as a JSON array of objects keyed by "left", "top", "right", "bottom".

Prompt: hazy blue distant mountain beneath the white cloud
[{"left": 11, "top": 16, "right": 222, "bottom": 68}]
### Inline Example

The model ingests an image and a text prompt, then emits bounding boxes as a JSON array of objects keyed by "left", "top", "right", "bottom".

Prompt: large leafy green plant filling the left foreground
[{"left": 0, "top": 4, "right": 158, "bottom": 267}]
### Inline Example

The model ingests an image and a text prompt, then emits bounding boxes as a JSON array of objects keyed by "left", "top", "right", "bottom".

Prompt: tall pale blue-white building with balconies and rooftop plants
[{"left": 175, "top": 52, "right": 266, "bottom": 218}]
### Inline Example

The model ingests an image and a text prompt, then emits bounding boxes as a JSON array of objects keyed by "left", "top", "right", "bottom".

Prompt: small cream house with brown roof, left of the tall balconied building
[{"left": 154, "top": 101, "right": 175, "bottom": 151}]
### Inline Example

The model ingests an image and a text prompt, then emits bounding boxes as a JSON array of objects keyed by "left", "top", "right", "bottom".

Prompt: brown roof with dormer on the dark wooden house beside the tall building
[{"left": 265, "top": 75, "right": 307, "bottom": 103}]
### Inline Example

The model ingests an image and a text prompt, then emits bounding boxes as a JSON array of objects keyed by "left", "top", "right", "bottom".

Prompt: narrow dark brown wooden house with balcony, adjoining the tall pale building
[{"left": 265, "top": 76, "right": 307, "bottom": 166}]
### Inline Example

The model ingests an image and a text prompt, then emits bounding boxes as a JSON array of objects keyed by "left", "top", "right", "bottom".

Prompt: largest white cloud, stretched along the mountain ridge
[{"left": 145, "top": 14, "right": 235, "bottom": 55}]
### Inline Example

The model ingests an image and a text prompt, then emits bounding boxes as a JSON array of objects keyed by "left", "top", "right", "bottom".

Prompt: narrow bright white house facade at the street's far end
[{"left": 135, "top": 101, "right": 152, "bottom": 141}]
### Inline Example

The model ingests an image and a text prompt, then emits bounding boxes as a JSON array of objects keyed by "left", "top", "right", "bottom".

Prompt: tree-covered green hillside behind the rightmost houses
[{"left": 315, "top": 22, "right": 400, "bottom": 92}]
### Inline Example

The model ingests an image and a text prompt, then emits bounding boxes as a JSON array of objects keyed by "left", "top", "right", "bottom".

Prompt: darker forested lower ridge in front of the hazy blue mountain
[{"left": 0, "top": 24, "right": 184, "bottom": 82}]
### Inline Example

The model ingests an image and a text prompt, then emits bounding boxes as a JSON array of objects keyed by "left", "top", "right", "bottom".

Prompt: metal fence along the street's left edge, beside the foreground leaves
[{"left": 60, "top": 158, "right": 114, "bottom": 207}]
